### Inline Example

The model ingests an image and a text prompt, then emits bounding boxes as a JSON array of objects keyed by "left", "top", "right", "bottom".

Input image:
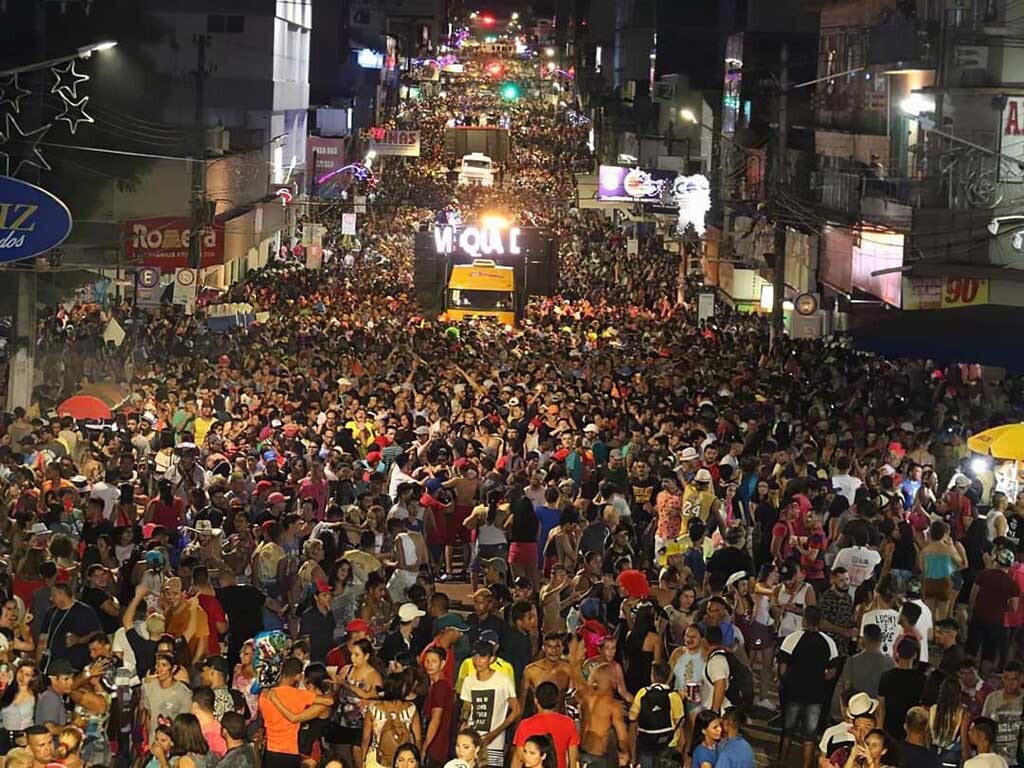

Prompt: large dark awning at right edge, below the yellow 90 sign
[{"left": 851, "top": 306, "right": 1024, "bottom": 371}]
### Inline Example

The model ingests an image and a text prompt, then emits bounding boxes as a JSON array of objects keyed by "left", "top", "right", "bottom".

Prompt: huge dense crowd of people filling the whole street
[{"left": 0, "top": 39, "right": 1024, "bottom": 768}]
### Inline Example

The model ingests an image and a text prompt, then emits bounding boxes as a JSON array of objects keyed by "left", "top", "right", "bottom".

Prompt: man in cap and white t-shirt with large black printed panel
[{"left": 459, "top": 640, "right": 521, "bottom": 765}]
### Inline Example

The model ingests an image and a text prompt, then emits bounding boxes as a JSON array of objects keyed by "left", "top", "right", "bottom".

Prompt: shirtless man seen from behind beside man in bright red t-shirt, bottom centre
[{"left": 569, "top": 638, "right": 630, "bottom": 768}]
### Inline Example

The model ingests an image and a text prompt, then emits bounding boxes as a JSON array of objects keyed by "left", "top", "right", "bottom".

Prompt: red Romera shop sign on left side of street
[{"left": 125, "top": 216, "right": 224, "bottom": 272}]
